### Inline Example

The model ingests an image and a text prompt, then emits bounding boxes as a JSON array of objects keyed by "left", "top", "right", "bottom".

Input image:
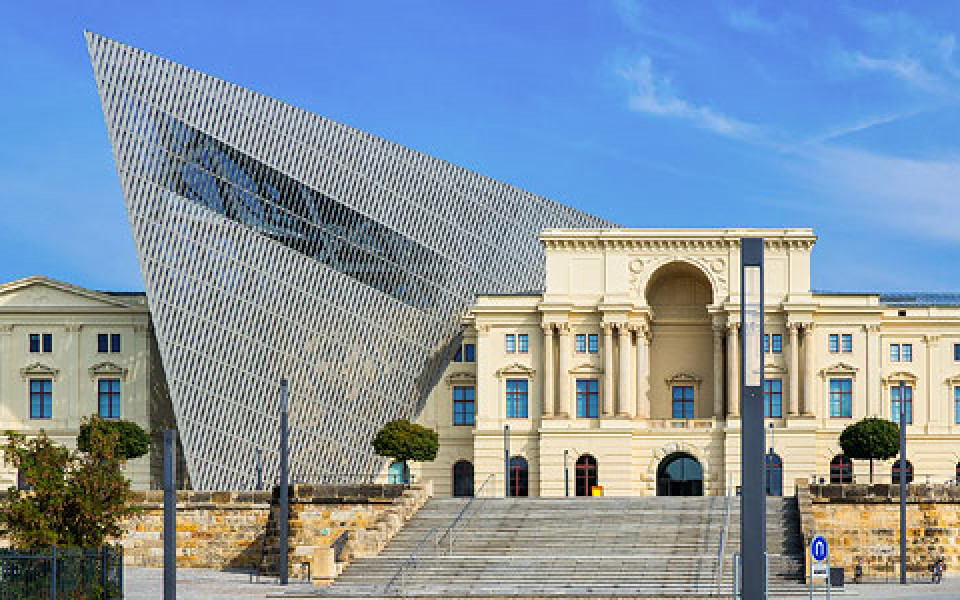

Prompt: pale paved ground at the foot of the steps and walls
[{"left": 124, "top": 567, "right": 960, "bottom": 600}]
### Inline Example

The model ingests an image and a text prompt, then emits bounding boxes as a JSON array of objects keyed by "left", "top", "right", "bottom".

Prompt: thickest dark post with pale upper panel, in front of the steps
[{"left": 740, "top": 238, "right": 767, "bottom": 600}]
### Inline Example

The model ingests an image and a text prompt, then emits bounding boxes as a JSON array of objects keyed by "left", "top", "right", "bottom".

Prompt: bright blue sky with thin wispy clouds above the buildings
[{"left": 0, "top": 0, "right": 960, "bottom": 291}]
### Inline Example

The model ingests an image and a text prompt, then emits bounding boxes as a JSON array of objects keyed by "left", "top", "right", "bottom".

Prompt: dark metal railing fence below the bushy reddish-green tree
[{"left": 0, "top": 546, "right": 123, "bottom": 600}]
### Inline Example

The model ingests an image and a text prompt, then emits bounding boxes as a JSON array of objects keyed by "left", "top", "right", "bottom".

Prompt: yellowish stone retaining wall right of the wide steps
[{"left": 797, "top": 480, "right": 960, "bottom": 579}]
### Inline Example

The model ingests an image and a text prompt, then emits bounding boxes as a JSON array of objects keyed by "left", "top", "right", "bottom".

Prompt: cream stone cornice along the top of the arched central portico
[{"left": 540, "top": 229, "right": 817, "bottom": 253}]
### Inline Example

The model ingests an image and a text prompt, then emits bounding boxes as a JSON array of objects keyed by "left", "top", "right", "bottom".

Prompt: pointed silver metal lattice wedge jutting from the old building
[{"left": 86, "top": 33, "right": 613, "bottom": 489}]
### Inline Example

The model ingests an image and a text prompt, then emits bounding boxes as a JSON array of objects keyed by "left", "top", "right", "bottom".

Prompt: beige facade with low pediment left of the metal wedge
[{"left": 0, "top": 277, "right": 162, "bottom": 489}]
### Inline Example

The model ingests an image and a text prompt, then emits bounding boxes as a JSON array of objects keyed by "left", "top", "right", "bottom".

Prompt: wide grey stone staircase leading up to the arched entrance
[{"left": 325, "top": 497, "right": 805, "bottom": 596}]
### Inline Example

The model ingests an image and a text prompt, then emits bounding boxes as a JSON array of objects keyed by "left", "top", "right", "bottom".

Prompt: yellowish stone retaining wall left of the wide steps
[{"left": 121, "top": 484, "right": 432, "bottom": 581}]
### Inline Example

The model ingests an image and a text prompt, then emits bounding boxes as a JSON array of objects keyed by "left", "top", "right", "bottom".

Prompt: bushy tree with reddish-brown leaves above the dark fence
[{"left": 0, "top": 418, "right": 138, "bottom": 548}]
